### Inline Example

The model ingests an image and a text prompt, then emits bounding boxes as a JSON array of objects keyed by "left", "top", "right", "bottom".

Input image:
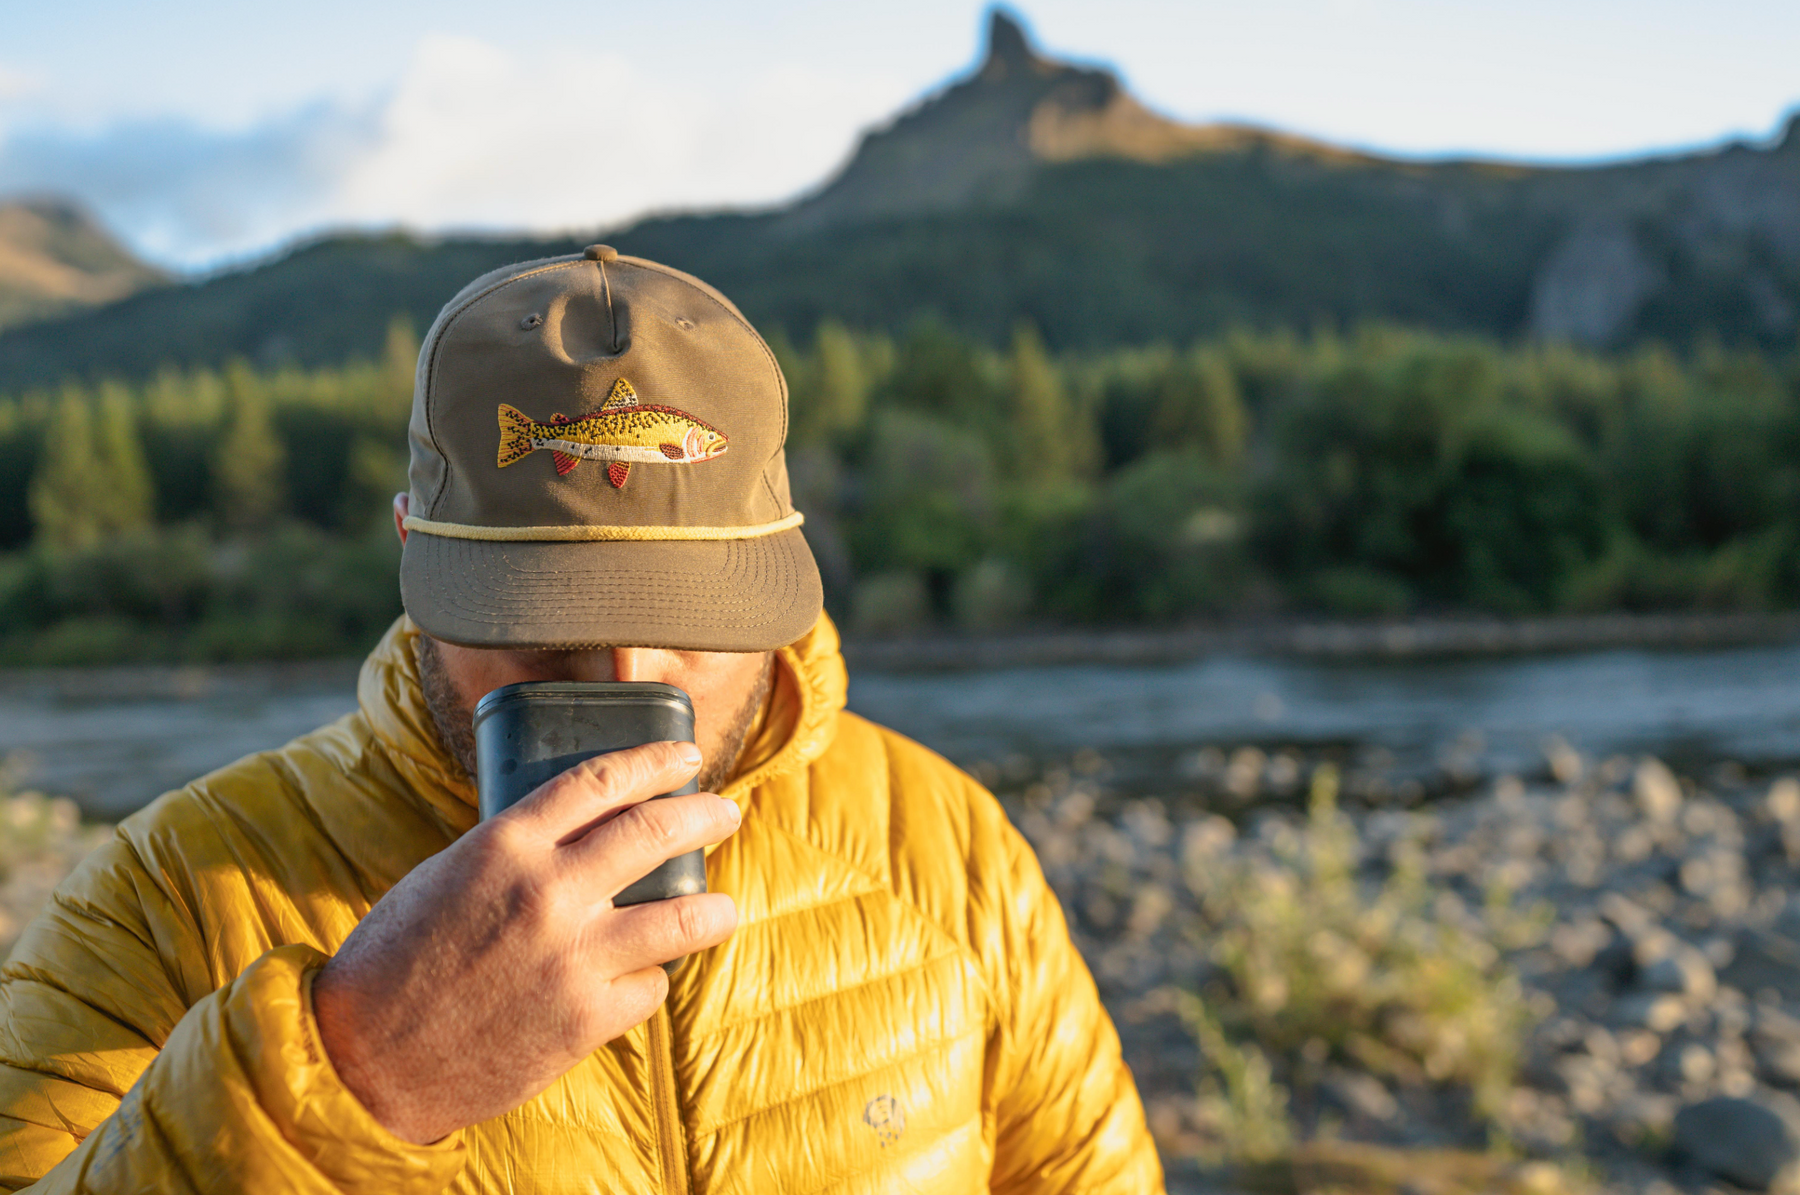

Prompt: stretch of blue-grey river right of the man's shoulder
[{"left": 850, "top": 644, "right": 1800, "bottom": 772}]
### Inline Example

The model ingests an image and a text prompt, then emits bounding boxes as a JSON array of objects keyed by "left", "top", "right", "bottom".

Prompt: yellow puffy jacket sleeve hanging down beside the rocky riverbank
[{"left": 983, "top": 813, "right": 1163, "bottom": 1195}]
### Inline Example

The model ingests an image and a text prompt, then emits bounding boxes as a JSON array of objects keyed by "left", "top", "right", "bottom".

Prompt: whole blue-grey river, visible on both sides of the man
[{"left": 10, "top": 644, "right": 1800, "bottom": 817}]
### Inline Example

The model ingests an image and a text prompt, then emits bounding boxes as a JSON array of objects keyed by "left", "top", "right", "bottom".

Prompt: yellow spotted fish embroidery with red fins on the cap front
[{"left": 499, "top": 378, "right": 725, "bottom": 490}]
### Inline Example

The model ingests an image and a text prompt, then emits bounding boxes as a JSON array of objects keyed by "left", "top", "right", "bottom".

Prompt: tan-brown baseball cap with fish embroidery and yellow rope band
[{"left": 400, "top": 245, "right": 821, "bottom": 651}]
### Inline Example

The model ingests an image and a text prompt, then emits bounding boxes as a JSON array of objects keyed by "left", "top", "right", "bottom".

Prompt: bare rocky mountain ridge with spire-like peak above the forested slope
[{"left": 792, "top": 9, "right": 1800, "bottom": 346}]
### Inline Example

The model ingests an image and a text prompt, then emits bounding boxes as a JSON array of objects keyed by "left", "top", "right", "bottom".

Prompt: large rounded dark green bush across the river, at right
[{"left": 1256, "top": 335, "right": 1616, "bottom": 614}]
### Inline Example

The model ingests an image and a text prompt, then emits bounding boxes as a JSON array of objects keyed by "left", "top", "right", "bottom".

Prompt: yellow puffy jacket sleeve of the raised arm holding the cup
[{"left": 0, "top": 839, "right": 463, "bottom": 1195}]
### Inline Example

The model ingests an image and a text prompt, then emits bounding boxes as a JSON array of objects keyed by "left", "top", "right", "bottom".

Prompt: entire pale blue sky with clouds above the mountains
[{"left": 0, "top": 0, "right": 1800, "bottom": 272}]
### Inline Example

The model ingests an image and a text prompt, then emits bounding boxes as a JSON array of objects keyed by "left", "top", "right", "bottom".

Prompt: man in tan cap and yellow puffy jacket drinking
[{"left": 0, "top": 245, "right": 1161, "bottom": 1195}]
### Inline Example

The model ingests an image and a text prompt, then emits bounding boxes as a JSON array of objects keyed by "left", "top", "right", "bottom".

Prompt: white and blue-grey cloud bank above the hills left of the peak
[{"left": 0, "top": 36, "right": 904, "bottom": 266}]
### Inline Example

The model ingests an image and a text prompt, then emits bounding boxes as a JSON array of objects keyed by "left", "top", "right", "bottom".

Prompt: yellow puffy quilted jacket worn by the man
[{"left": 0, "top": 619, "right": 1163, "bottom": 1195}]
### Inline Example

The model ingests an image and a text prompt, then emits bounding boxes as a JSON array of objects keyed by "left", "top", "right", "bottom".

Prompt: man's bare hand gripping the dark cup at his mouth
[{"left": 313, "top": 743, "right": 738, "bottom": 1145}]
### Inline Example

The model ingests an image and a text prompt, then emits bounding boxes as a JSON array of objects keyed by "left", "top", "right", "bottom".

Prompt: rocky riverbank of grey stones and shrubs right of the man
[{"left": 977, "top": 743, "right": 1800, "bottom": 1191}]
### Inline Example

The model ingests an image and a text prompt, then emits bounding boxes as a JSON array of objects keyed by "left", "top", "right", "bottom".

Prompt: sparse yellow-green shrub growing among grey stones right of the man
[{"left": 1186, "top": 765, "right": 1544, "bottom": 1123}]
